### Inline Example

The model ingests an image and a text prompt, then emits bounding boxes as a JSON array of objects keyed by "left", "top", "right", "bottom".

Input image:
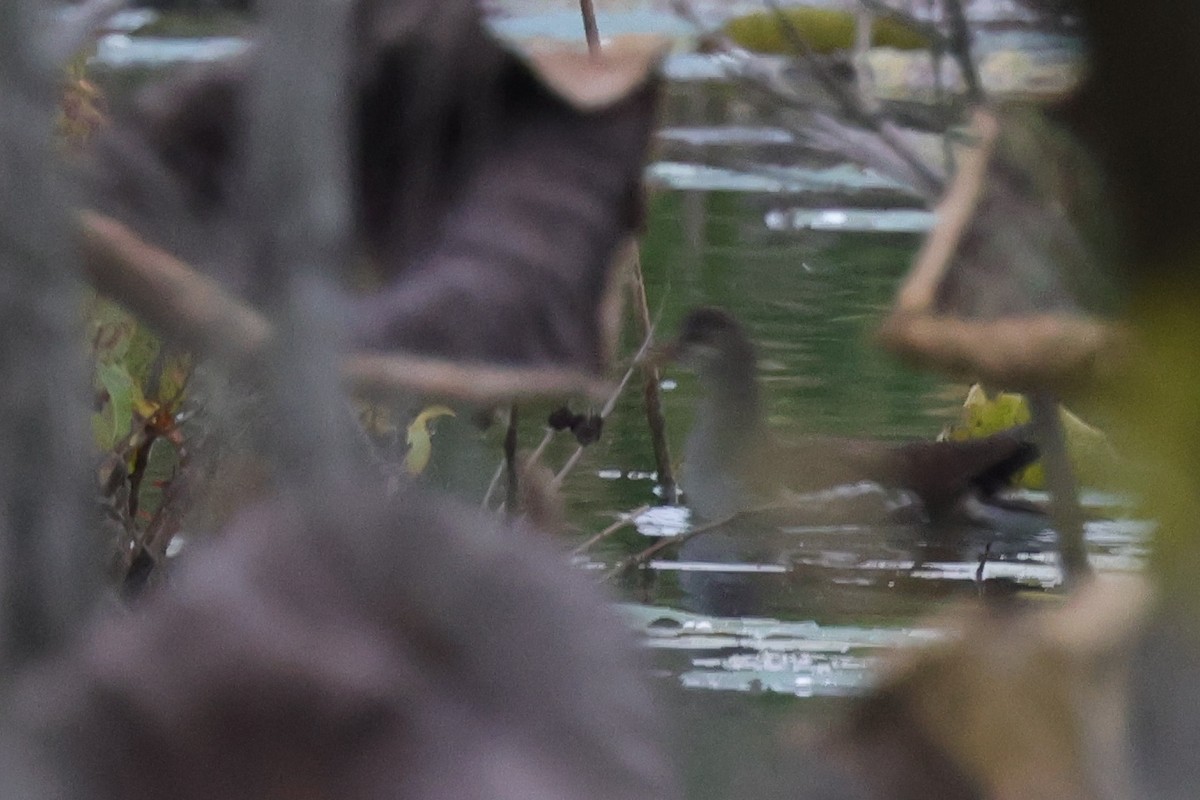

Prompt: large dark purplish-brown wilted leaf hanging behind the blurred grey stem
[{"left": 84, "top": 9, "right": 661, "bottom": 387}]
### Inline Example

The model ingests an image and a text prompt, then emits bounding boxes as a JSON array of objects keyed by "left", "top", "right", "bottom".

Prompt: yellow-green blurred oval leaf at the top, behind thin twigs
[{"left": 725, "top": 6, "right": 929, "bottom": 54}]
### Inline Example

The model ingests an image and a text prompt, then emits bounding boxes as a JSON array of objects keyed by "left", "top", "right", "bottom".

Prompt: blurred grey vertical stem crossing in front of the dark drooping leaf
[{"left": 244, "top": 0, "right": 359, "bottom": 499}]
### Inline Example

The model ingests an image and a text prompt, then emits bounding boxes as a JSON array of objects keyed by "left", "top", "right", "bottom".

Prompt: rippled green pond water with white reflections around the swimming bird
[{"left": 550, "top": 173, "right": 1148, "bottom": 697}]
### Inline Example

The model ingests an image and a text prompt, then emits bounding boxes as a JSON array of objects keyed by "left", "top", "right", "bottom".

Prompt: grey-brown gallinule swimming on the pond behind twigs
[{"left": 661, "top": 308, "right": 1040, "bottom": 528}]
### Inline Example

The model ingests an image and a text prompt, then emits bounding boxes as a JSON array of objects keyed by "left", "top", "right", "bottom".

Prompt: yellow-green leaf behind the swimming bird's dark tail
[{"left": 943, "top": 384, "right": 1124, "bottom": 489}]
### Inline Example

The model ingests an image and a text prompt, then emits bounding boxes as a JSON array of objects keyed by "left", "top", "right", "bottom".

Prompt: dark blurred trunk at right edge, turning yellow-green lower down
[{"left": 1062, "top": 0, "right": 1200, "bottom": 618}]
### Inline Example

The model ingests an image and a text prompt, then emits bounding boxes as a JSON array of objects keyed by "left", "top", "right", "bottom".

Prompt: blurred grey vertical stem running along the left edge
[{"left": 0, "top": 0, "right": 93, "bottom": 676}]
